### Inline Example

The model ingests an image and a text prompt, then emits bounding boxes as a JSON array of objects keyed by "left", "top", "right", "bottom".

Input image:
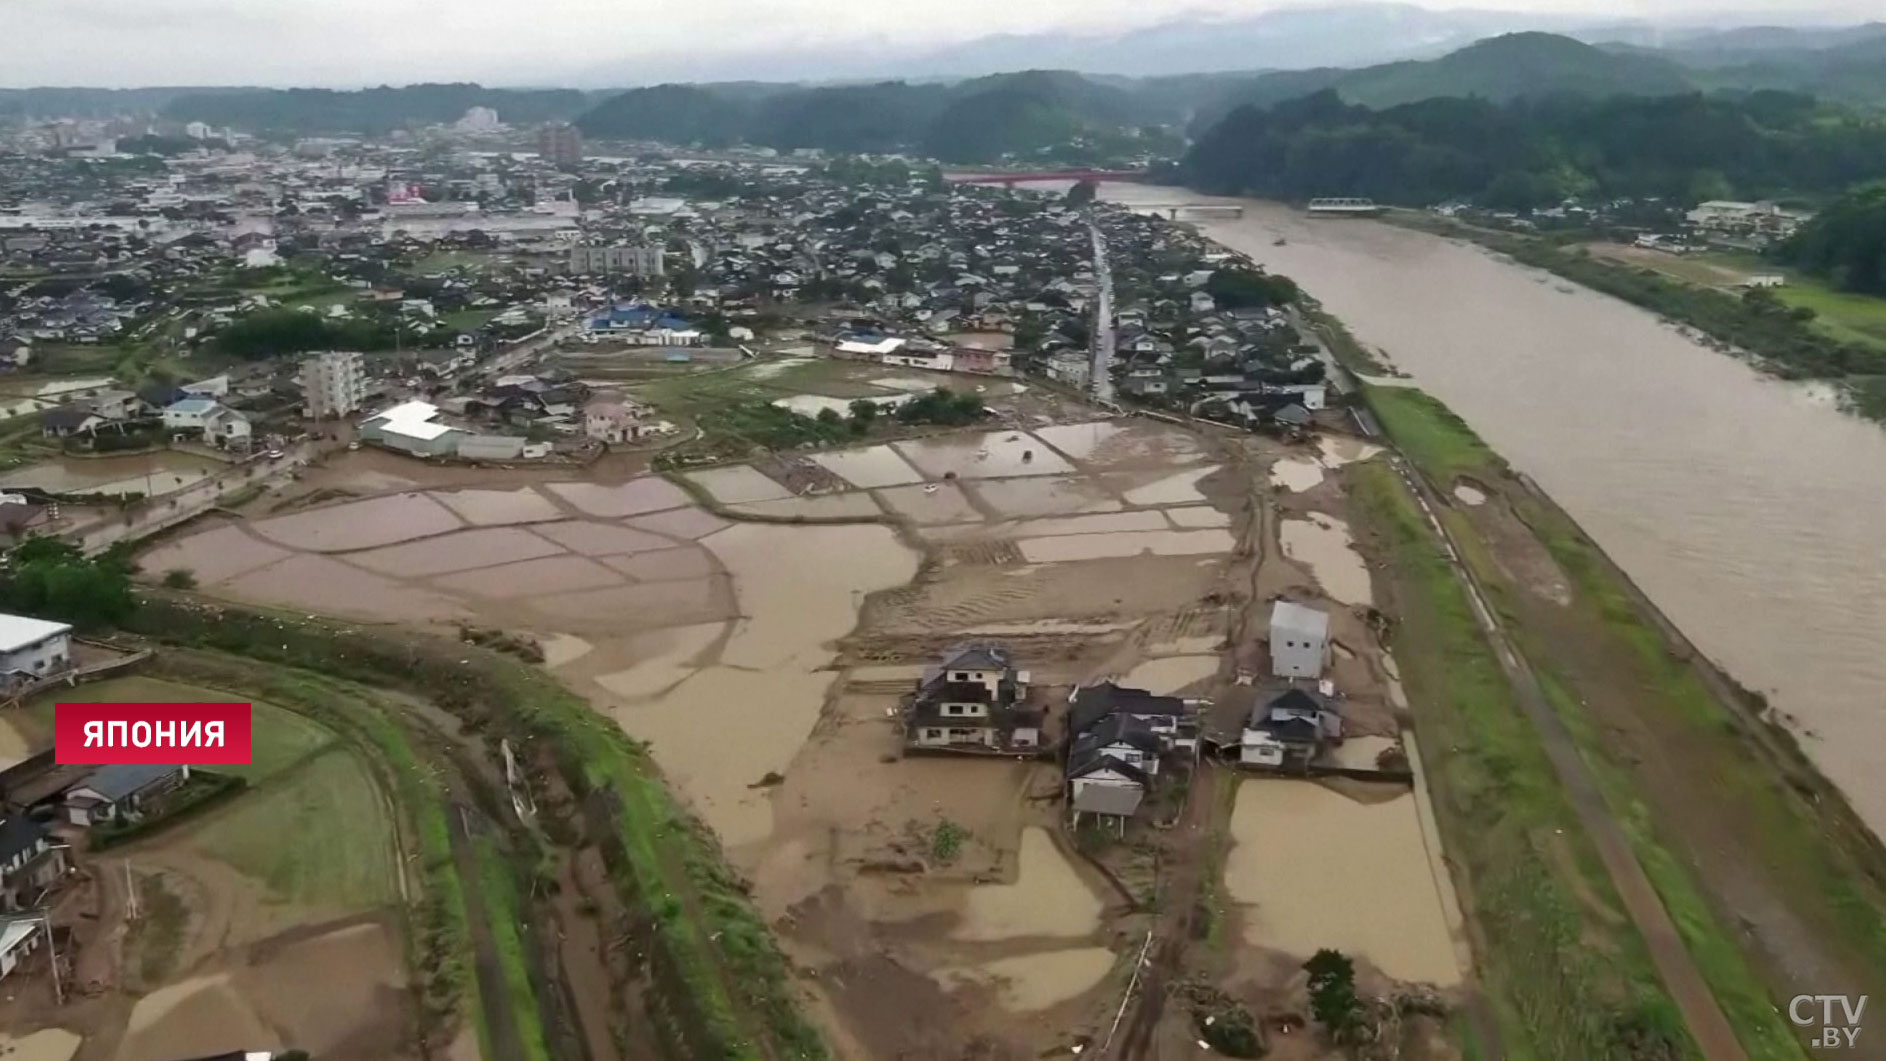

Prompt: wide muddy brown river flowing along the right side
[{"left": 1103, "top": 185, "right": 1886, "bottom": 833}]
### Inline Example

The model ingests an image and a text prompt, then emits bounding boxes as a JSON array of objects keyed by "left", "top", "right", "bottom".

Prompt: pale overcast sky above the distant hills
[{"left": 0, "top": 0, "right": 1877, "bottom": 87}]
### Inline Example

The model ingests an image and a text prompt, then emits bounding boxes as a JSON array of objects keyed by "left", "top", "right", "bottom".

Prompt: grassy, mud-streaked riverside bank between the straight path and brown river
[{"left": 1365, "top": 380, "right": 1886, "bottom": 1059}]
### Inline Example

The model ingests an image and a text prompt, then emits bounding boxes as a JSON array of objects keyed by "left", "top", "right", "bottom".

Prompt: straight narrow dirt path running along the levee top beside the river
[{"left": 1394, "top": 456, "right": 1748, "bottom": 1061}]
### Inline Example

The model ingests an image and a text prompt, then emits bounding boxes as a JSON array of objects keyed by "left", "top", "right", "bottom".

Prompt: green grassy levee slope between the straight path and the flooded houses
[{"left": 1348, "top": 462, "right": 1697, "bottom": 1061}]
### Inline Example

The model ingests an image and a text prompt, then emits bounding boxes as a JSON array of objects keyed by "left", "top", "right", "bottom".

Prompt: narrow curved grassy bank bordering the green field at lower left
[{"left": 134, "top": 648, "right": 485, "bottom": 1037}]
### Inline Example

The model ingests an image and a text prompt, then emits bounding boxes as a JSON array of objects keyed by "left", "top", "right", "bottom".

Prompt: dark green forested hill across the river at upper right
[{"left": 1181, "top": 90, "right": 1886, "bottom": 209}]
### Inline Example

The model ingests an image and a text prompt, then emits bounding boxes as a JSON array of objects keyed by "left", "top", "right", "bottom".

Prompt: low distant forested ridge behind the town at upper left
[{"left": 162, "top": 85, "right": 588, "bottom": 136}]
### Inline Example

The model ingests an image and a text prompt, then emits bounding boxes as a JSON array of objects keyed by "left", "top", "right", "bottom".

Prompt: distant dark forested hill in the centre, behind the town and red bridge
[{"left": 577, "top": 70, "right": 1179, "bottom": 164}]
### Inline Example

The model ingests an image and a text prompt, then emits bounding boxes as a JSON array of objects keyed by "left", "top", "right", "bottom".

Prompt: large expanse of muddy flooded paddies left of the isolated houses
[{"left": 147, "top": 420, "right": 1418, "bottom": 1057}]
